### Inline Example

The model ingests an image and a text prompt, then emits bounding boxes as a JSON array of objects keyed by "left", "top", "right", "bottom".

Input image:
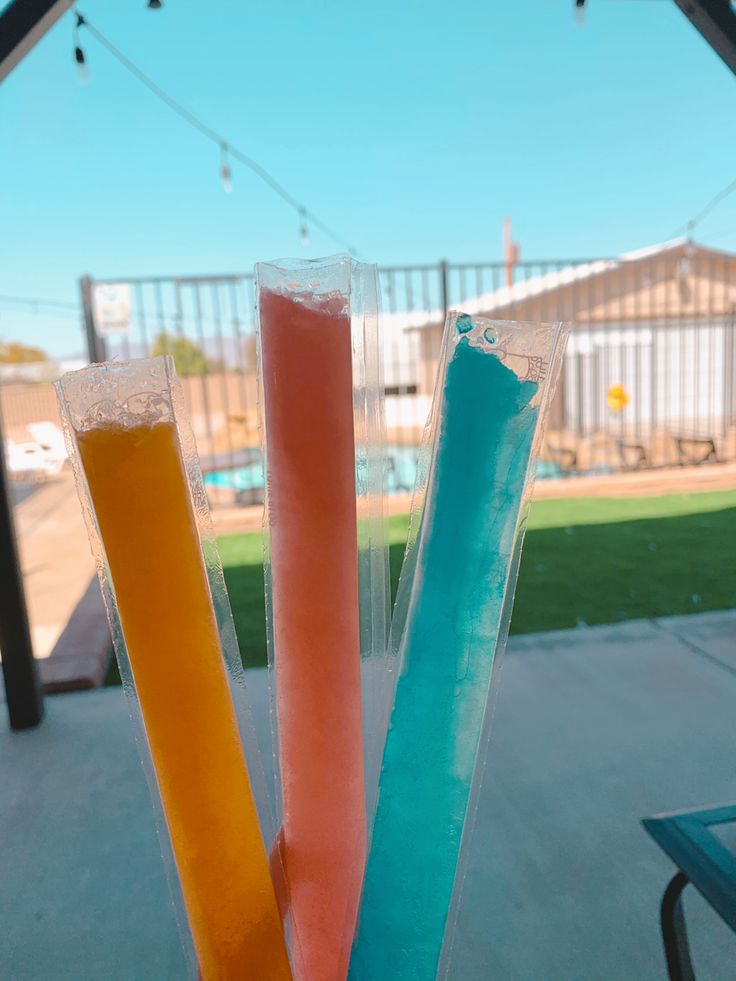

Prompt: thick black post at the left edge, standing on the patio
[{"left": 0, "top": 428, "right": 43, "bottom": 729}]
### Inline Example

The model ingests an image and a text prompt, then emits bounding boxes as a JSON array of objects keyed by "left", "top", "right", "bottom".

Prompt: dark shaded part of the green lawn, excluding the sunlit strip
[{"left": 107, "top": 508, "right": 736, "bottom": 684}]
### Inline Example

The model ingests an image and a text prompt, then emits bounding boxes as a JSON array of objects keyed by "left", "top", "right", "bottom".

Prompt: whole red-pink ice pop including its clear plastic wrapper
[{"left": 256, "top": 256, "right": 390, "bottom": 981}]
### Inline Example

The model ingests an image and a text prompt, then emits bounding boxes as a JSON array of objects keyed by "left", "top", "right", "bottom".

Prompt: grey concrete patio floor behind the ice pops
[{"left": 0, "top": 611, "right": 736, "bottom": 981}]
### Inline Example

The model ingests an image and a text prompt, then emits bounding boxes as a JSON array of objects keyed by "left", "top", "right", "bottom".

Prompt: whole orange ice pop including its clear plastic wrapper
[{"left": 56, "top": 357, "right": 291, "bottom": 981}]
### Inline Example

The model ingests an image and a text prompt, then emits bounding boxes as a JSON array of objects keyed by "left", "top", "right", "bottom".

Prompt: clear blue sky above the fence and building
[{"left": 0, "top": 0, "right": 736, "bottom": 354}]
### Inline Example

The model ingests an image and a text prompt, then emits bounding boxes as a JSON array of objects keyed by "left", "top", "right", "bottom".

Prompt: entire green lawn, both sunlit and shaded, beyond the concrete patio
[{"left": 103, "top": 491, "right": 736, "bottom": 681}]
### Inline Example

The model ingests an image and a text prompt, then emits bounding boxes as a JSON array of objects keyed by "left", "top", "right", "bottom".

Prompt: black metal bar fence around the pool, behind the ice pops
[{"left": 77, "top": 249, "right": 736, "bottom": 500}]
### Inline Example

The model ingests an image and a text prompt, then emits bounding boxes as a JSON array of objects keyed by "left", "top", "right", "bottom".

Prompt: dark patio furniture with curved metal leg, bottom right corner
[{"left": 642, "top": 804, "right": 736, "bottom": 981}]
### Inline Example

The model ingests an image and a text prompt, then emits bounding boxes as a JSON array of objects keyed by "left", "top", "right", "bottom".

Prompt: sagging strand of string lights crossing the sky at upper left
[{"left": 70, "top": 11, "right": 357, "bottom": 255}]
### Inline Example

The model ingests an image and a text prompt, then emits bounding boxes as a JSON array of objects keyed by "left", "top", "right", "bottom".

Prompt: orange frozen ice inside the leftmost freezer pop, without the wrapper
[{"left": 77, "top": 422, "right": 291, "bottom": 981}]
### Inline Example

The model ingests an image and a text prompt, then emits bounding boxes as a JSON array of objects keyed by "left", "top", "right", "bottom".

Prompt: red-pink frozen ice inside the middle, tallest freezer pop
[{"left": 259, "top": 291, "right": 365, "bottom": 981}]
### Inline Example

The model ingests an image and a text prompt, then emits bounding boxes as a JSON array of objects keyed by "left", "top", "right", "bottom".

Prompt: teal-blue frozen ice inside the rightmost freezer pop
[{"left": 349, "top": 337, "right": 537, "bottom": 981}]
